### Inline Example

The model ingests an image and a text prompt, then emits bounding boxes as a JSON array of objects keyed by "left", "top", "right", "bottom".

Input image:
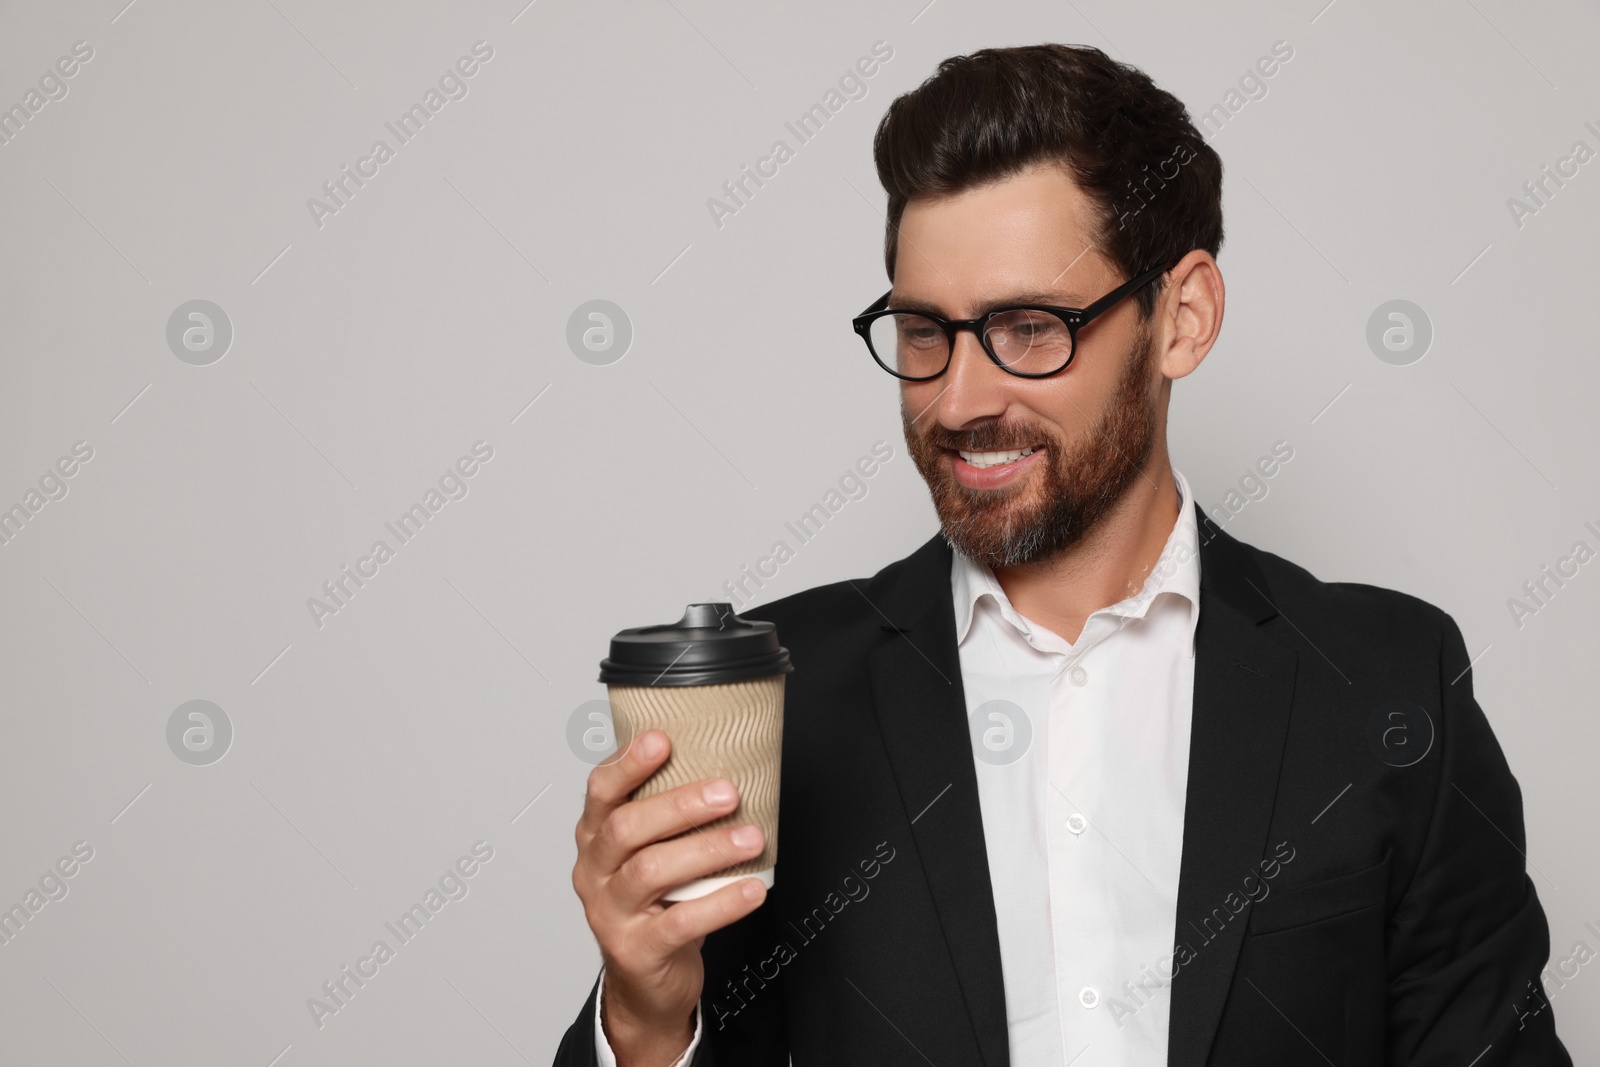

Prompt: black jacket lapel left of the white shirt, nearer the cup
[{"left": 858, "top": 534, "right": 1010, "bottom": 1067}]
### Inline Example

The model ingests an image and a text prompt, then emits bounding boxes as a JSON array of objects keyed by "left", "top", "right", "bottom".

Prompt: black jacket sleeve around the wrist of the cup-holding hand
[{"left": 554, "top": 894, "right": 789, "bottom": 1067}]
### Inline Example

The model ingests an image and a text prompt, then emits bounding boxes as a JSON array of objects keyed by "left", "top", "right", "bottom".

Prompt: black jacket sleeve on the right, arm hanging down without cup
[{"left": 1387, "top": 616, "right": 1571, "bottom": 1067}]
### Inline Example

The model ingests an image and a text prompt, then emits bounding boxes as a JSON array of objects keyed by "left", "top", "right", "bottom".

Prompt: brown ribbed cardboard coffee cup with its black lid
[{"left": 600, "top": 603, "right": 794, "bottom": 901}]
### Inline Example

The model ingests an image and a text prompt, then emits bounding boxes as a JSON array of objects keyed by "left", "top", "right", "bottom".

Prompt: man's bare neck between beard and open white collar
[{"left": 995, "top": 450, "right": 1179, "bottom": 643}]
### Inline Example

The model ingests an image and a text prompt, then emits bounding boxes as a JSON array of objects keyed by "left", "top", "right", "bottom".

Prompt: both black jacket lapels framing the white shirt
[{"left": 858, "top": 507, "right": 1296, "bottom": 1067}]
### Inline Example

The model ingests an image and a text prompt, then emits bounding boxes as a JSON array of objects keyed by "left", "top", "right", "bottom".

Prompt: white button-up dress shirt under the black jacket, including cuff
[{"left": 595, "top": 469, "right": 1200, "bottom": 1067}]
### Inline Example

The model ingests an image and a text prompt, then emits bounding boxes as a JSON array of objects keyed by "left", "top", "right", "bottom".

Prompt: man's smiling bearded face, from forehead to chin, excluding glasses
[{"left": 890, "top": 165, "right": 1163, "bottom": 568}]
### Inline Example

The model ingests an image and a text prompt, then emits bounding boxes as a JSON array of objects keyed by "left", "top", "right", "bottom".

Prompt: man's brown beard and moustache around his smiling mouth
[{"left": 901, "top": 323, "right": 1158, "bottom": 569}]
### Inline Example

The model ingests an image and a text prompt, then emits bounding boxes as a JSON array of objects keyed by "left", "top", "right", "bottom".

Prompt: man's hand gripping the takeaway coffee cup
[{"left": 573, "top": 729, "right": 766, "bottom": 1067}]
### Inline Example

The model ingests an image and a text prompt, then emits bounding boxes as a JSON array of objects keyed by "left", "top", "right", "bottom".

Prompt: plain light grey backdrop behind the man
[{"left": 0, "top": 0, "right": 1600, "bottom": 1067}]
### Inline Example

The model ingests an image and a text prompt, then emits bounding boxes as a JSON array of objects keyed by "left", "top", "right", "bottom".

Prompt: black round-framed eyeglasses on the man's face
[{"left": 851, "top": 267, "right": 1168, "bottom": 382}]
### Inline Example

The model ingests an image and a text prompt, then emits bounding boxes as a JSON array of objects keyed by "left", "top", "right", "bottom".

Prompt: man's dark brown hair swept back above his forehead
[{"left": 872, "top": 45, "right": 1222, "bottom": 322}]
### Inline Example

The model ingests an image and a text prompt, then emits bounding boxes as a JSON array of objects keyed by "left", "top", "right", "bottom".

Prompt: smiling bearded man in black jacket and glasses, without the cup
[{"left": 557, "top": 45, "right": 1570, "bottom": 1067}]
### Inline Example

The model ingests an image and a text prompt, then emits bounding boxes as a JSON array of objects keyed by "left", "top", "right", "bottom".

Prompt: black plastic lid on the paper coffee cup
[{"left": 600, "top": 601, "right": 794, "bottom": 686}]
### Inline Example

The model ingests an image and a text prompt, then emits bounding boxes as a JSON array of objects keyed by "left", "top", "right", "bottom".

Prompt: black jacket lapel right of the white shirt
[{"left": 1166, "top": 507, "right": 1298, "bottom": 1067}]
